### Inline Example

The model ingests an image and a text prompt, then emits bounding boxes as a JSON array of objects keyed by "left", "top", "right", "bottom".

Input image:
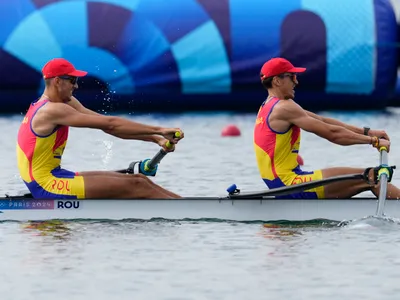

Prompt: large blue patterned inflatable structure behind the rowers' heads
[{"left": 0, "top": 0, "right": 397, "bottom": 112}]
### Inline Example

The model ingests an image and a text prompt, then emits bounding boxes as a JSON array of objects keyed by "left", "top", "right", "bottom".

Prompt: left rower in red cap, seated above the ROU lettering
[{"left": 17, "top": 58, "right": 184, "bottom": 199}]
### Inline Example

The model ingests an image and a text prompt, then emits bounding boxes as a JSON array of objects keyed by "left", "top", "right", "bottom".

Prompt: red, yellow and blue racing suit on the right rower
[{"left": 254, "top": 97, "right": 324, "bottom": 198}]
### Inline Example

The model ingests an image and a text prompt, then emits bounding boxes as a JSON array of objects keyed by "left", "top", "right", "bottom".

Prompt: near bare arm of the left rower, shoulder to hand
[{"left": 43, "top": 103, "right": 180, "bottom": 140}]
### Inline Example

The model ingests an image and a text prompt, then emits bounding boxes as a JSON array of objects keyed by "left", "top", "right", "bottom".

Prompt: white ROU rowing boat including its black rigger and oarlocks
[{"left": 0, "top": 141, "right": 394, "bottom": 221}]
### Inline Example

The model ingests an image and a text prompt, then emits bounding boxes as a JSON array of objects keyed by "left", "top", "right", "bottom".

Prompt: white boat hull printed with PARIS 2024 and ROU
[{"left": 0, "top": 198, "right": 400, "bottom": 221}]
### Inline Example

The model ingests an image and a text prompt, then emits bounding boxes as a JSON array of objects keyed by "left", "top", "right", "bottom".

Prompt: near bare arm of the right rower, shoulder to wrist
[{"left": 274, "top": 100, "right": 372, "bottom": 146}]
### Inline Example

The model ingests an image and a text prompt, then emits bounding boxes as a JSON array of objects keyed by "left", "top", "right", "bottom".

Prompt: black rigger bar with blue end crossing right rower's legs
[{"left": 227, "top": 174, "right": 365, "bottom": 199}]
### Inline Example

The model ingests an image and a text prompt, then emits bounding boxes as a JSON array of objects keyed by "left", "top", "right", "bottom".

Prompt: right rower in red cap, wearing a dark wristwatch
[{"left": 254, "top": 57, "right": 400, "bottom": 199}]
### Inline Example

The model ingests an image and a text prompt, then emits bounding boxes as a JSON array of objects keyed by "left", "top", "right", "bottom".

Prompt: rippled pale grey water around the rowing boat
[{"left": 0, "top": 110, "right": 400, "bottom": 300}]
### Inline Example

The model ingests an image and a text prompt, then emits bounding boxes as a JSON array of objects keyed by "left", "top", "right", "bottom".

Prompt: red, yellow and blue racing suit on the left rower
[{"left": 17, "top": 100, "right": 85, "bottom": 199}]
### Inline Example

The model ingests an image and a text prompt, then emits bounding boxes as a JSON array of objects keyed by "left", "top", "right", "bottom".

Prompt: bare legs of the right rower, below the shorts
[{"left": 322, "top": 167, "right": 400, "bottom": 199}]
